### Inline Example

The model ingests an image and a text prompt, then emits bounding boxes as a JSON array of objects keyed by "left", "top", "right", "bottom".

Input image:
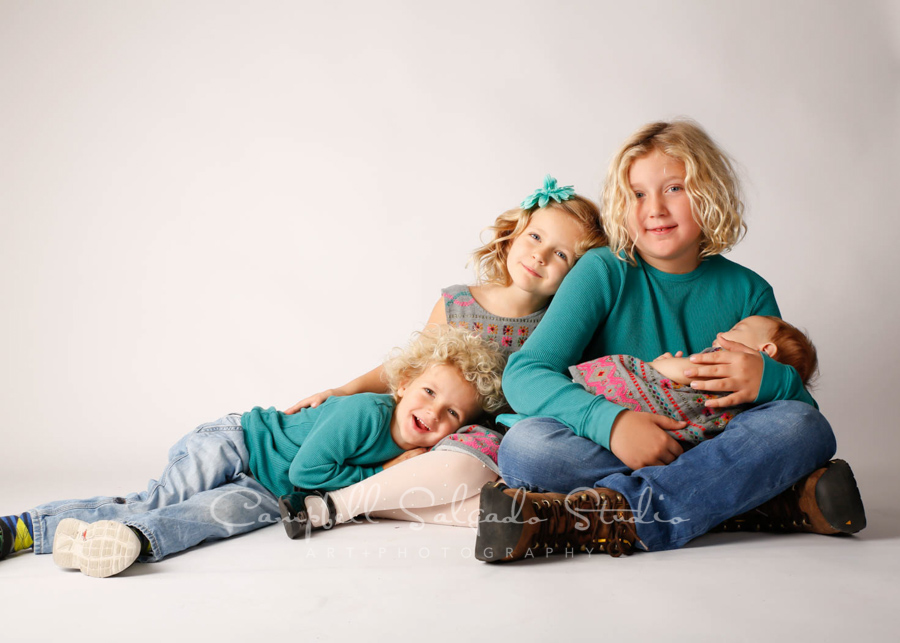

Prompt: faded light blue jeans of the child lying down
[{"left": 31, "top": 414, "right": 280, "bottom": 562}]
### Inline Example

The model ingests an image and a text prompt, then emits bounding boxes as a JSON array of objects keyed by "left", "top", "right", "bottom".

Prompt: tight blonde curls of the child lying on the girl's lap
[{"left": 384, "top": 325, "right": 506, "bottom": 413}]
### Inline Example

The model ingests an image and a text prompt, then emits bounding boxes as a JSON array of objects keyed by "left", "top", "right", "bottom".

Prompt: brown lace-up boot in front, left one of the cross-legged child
[{"left": 475, "top": 482, "right": 639, "bottom": 562}]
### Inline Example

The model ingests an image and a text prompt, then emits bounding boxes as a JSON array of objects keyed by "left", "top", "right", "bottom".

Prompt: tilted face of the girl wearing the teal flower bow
[{"left": 506, "top": 208, "right": 584, "bottom": 298}]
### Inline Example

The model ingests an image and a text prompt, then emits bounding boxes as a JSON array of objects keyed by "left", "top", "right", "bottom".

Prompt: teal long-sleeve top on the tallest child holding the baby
[{"left": 503, "top": 248, "right": 818, "bottom": 449}]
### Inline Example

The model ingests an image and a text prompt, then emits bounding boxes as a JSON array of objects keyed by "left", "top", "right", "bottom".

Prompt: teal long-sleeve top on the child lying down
[{"left": 241, "top": 393, "right": 403, "bottom": 496}]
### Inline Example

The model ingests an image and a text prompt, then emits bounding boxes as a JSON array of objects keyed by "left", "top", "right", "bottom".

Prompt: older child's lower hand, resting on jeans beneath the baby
[{"left": 609, "top": 411, "right": 687, "bottom": 470}]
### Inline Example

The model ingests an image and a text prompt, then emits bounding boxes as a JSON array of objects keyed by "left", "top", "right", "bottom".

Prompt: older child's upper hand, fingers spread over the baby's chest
[{"left": 684, "top": 334, "right": 764, "bottom": 408}]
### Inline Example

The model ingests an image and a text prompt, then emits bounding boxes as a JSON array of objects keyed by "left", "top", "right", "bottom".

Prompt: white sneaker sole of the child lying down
[{"left": 53, "top": 518, "right": 141, "bottom": 578}]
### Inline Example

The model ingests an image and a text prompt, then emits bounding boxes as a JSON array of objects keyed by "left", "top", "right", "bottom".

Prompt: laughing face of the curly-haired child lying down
[{"left": 391, "top": 364, "right": 481, "bottom": 449}]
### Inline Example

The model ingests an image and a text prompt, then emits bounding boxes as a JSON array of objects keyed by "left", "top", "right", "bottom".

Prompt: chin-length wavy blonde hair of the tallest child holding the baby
[{"left": 601, "top": 119, "right": 747, "bottom": 264}]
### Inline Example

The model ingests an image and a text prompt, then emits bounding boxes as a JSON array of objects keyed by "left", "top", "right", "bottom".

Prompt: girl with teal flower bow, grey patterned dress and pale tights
[{"left": 282, "top": 175, "right": 606, "bottom": 535}]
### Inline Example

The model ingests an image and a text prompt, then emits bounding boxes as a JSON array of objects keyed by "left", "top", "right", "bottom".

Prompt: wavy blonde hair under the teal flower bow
[{"left": 472, "top": 195, "right": 607, "bottom": 286}]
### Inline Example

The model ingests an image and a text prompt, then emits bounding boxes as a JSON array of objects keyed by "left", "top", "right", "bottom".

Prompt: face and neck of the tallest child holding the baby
[{"left": 627, "top": 151, "right": 702, "bottom": 274}]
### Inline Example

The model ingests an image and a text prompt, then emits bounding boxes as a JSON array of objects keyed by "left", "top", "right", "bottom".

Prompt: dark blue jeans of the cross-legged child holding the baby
[{"left": 499, "top": 401, "right": 836, "bottom": 551}]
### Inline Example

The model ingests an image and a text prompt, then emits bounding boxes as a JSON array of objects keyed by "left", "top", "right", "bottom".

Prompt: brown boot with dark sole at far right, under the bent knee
[{"left": 712, "top": 460, "right": 866, "bottom": 534}]
